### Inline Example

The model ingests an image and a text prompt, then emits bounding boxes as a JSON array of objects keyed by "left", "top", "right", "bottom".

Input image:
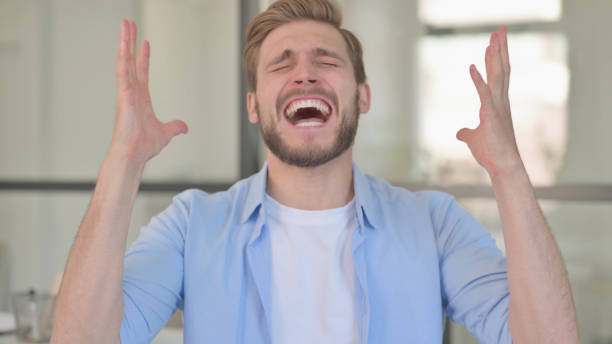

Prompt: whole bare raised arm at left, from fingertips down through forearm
[{"left": 51, "top": 20, "right": 187, "bottom": 344}]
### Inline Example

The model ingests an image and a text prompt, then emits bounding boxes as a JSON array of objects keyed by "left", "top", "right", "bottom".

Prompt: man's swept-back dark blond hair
[{"left": 242, "top": 0, "right": 366, "bottom": 91}]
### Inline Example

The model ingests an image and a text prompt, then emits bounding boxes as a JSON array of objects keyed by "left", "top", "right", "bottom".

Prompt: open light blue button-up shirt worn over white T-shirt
[{"left": 121, "top": 165, "right": 512, "bottom": 344}]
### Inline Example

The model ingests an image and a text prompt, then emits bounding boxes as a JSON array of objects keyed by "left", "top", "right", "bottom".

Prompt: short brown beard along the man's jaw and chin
[{"left": 255, "top": 92, "right": 359, "bottom": 167}]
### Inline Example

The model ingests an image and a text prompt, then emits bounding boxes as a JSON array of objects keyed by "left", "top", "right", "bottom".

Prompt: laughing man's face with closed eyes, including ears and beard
[{"left": 247, "top": 20, "right": 370, "bottom": 167}]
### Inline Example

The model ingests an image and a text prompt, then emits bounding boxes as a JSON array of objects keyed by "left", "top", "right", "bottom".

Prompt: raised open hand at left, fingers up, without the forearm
[{"left": 111, "top": 20, "right": 187, "bottom": 163}]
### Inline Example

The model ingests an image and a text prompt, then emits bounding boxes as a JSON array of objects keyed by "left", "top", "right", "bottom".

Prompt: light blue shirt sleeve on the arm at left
[{"left": 120, "top": 193, "right": 188, "bottom": 344}]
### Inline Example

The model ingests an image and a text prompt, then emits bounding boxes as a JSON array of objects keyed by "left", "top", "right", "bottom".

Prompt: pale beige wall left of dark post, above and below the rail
[{"left": 0, "top": 0, "right": 240, "bottom": 298}]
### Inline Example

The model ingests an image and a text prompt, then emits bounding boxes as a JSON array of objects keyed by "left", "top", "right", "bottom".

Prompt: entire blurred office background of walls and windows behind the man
[{"left": 0, "top": 0, "right": 612, "bottom": 344}]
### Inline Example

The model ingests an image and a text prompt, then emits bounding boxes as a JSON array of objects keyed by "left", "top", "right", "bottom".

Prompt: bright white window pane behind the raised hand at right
[{"left": 417, "top": 32, "right": 569, "bottom": 185}]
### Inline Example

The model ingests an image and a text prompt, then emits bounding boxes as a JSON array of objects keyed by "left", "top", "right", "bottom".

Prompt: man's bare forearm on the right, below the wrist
[{"left": 491, "top": 164, "right": 579, "bottom": 343}]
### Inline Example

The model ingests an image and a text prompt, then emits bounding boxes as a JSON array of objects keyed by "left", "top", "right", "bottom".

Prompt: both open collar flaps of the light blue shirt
[{"left": 240, "top": 161, "right": 381, "bottom": 228}]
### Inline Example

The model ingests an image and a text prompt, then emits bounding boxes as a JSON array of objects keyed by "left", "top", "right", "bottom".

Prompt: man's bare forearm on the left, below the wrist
[{"left": 53, "top": 153, "right": 144, "bottom": 343}]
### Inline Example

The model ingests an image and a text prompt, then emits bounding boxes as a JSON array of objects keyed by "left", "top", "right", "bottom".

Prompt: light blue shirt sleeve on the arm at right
[{"left": 433, "top": 195, "right": 512, "bottom": 343}]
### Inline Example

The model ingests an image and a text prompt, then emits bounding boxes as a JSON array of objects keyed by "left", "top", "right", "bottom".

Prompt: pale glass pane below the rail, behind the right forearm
[{"left": 451, "top": 199, "right": 612, "bottom": 344}]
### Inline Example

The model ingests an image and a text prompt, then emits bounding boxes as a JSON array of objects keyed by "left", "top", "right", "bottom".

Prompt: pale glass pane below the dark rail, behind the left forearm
[{"left": 0, "top": 191, "right": 173, "bottom": 300}]
